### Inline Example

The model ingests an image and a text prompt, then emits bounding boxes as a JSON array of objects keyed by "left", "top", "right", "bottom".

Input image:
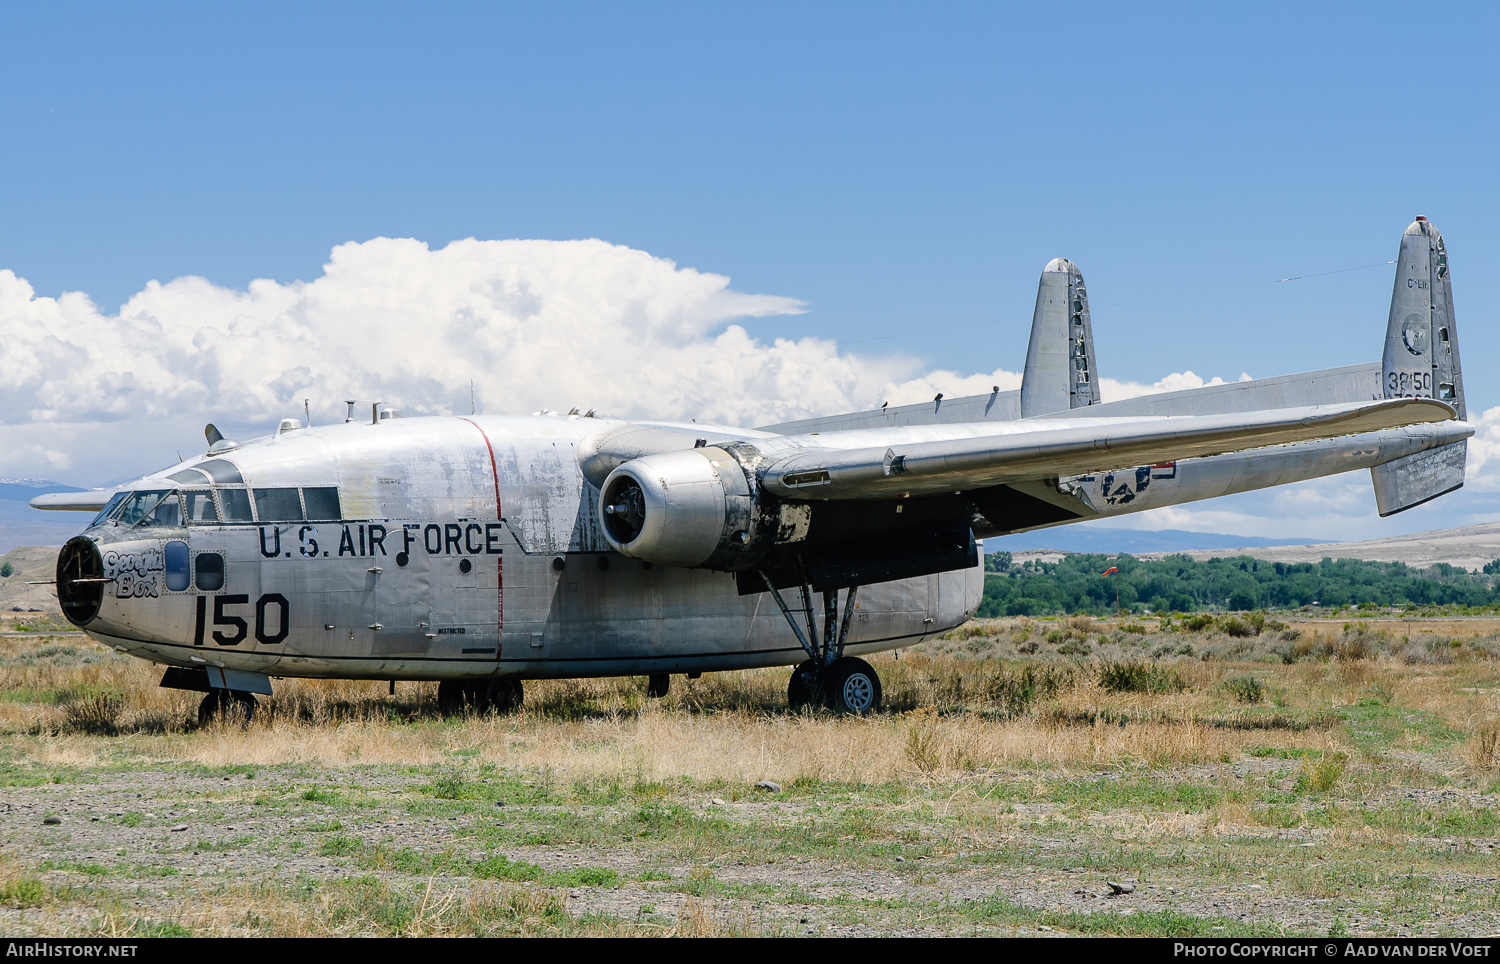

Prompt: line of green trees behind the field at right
[{"left": 978, "top": 552, "right": 1500, "bottom": 616}]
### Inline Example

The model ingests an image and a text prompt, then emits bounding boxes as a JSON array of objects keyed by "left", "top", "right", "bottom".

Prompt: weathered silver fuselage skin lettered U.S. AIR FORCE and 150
[{"left": 86, "top": 415, "right": 983, "bottom": 679}]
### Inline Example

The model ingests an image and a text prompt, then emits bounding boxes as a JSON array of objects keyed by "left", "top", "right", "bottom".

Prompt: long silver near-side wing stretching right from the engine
[{"left": 755, "top": 399, "right": 1472, "bottom": 499}]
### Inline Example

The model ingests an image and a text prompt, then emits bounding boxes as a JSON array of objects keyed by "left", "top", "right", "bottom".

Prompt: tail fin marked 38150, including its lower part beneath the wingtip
[{"left": 1370, "top": 216, "right": 1469, "bottom": 516}]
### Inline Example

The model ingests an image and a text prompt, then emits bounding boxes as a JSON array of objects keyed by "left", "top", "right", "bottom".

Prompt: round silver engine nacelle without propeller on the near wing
[{"left": 599, "top": 447, "right": 812, "bottom": 570}]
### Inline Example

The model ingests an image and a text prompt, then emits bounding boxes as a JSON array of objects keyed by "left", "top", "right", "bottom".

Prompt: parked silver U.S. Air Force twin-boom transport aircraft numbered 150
[{"left": 32, "top": 217, "right": 1473, "bottom": 720}]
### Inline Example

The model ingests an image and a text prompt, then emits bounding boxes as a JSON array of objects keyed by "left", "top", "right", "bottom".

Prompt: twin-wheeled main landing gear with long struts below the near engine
[{"left": 761, "top": 573, "right": 881, "bottom": 714}]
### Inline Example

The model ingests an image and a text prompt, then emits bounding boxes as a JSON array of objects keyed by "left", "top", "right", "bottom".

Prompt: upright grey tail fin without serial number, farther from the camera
[{"left": 1022, "top": 258, "right": 1100, "bottom": 418}]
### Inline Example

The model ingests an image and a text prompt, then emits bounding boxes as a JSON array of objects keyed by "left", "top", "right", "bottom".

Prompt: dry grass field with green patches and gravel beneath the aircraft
[{"left": 0, "top": 613, "right": 1500, "bottom": 936}]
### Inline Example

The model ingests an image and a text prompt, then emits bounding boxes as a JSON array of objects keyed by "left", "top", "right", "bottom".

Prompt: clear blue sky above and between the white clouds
[{"left": 0, "top": 3, "right": 1500, "bottom": 535}]
